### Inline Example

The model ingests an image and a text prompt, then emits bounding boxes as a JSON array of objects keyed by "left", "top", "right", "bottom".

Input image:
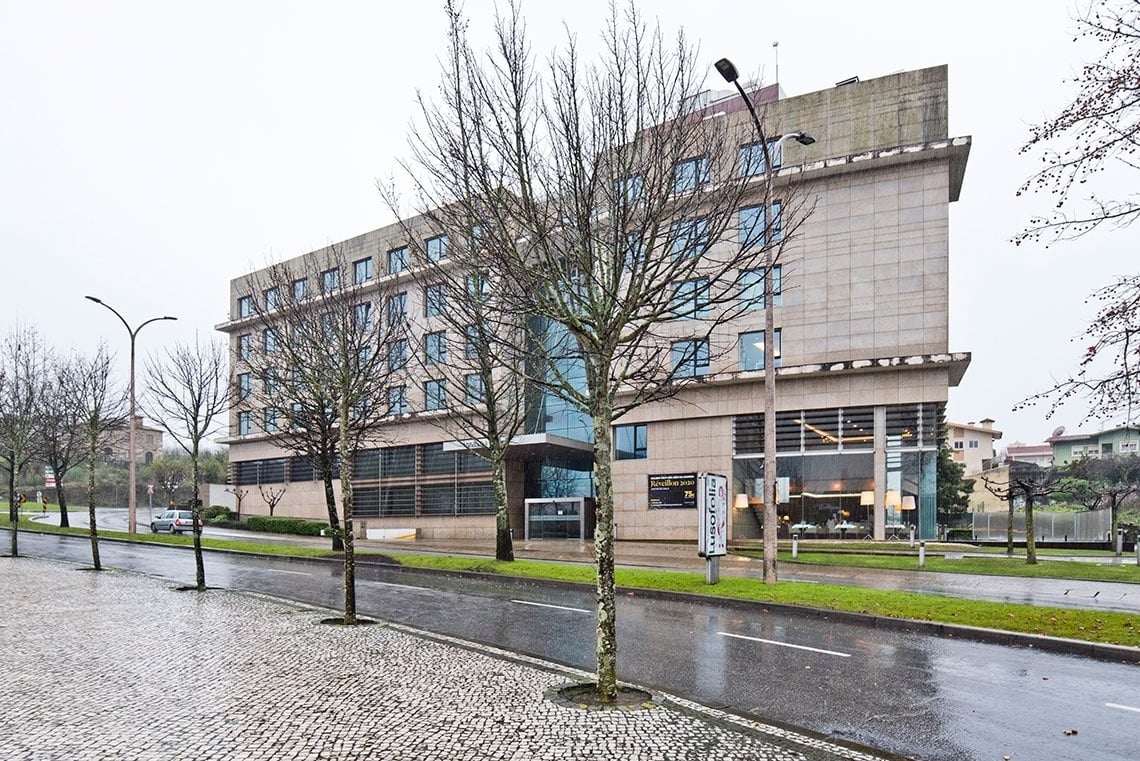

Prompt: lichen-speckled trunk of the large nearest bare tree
[{"left": 593, "top": 394, "right": 618, "bottom": 703}]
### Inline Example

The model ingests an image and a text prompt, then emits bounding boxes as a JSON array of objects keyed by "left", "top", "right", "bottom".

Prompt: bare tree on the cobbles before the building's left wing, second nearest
[{"left": 234, "top": 248, "right": 405, "bottom": 624}]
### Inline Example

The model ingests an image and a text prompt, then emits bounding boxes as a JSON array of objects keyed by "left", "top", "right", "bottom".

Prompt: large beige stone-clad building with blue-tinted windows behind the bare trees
[{"left": 219, "top": 66, "right": 970, "bottom": 540}]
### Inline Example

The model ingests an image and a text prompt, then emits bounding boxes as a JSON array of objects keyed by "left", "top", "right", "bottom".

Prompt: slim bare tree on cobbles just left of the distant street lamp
[{"left": 71, "top": 343, "right": 128, "bottom": 571}]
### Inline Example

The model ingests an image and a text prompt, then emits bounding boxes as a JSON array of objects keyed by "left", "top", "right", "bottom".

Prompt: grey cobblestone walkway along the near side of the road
[{"left": 0, "top": 557, "right": 879, "bottom": 761}]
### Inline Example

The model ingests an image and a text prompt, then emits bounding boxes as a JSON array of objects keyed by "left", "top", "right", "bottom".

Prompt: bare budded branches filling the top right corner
[{"left": 1013, "top": 0, "right": 1140, "bottom": 244}]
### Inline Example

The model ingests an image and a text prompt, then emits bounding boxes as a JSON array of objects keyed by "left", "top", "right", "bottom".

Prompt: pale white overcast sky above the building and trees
[{"left": 0, "top": 0, "right": 1140, "bottom": 444}]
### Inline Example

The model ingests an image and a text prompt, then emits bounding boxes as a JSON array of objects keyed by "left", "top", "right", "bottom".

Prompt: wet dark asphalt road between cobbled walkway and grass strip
[{"left": 11, "top": 533, "right": 1140, "bottom": 761}]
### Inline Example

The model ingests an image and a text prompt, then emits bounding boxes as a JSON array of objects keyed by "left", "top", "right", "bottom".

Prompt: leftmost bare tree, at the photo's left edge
[{"left": 0, "top": 325, "right": 48, "bottom": 557}]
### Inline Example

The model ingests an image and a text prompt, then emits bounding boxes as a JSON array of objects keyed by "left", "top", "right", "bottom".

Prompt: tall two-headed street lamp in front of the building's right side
[{"left": 714, "top": 58, "right": 815, "bottom": 584}]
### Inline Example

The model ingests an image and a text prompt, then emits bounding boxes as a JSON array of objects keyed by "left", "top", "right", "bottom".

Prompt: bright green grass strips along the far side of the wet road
[{"left": 0, "top": 514, "right": 1140, "bottom": 647}]
